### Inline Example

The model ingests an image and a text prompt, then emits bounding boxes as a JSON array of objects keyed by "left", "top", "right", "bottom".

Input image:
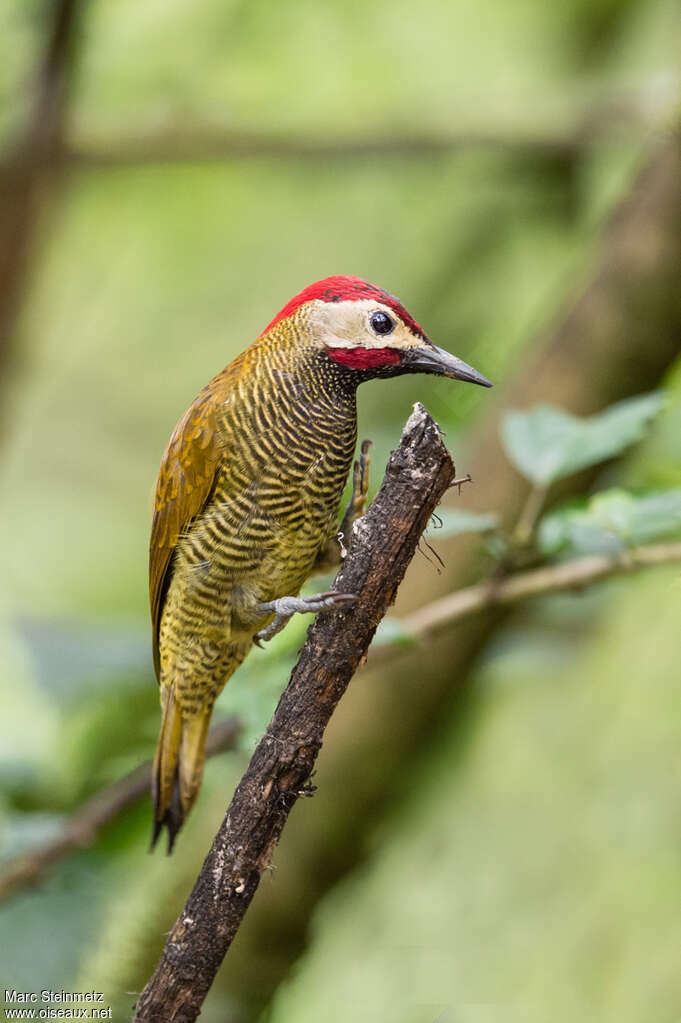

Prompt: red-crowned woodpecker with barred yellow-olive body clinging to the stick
[{"left": 149, "top": 276, "right": 491, "bottom": 852}]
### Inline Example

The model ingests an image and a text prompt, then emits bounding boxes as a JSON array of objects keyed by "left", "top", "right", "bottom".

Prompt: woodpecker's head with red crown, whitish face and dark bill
[{"left": 258, "top": 276, "right": 492, "bottom": 387}]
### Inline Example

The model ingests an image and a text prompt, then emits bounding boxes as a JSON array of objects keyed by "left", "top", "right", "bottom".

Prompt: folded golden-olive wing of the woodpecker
[{"left": 149, "top": 388, "right": 219, "bottom": 679}]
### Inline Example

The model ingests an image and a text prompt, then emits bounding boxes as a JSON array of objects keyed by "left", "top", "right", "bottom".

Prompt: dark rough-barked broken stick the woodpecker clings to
[{"left": 130, "top": 405, "right": 455, "bottom": 1023}]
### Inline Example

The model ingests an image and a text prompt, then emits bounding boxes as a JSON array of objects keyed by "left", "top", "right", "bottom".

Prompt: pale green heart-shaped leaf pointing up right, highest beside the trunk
[{"left": 501, "top": 392, "right": 664, "bottom": 487}]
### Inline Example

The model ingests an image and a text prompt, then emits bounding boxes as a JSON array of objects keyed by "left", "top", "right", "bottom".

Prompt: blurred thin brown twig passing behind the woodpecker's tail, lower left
[{"left": 0, "top": 717, "right": 241, "bottom": 900}]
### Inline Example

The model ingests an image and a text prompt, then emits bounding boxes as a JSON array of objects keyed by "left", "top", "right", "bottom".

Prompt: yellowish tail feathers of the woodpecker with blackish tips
[{"left": 151, "top": 688, "right": 213, "bottom": 853}]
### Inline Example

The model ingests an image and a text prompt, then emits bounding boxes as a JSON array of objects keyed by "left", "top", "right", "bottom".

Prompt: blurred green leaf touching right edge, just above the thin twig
[{"left": 538, "top": 487, "right": 681, "bottom": 555}]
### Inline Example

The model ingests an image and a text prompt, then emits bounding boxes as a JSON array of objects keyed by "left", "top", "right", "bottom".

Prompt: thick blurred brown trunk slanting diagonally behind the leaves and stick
[{"left": 225, "top": 131, "right": 681, "bottom": 1011}]
